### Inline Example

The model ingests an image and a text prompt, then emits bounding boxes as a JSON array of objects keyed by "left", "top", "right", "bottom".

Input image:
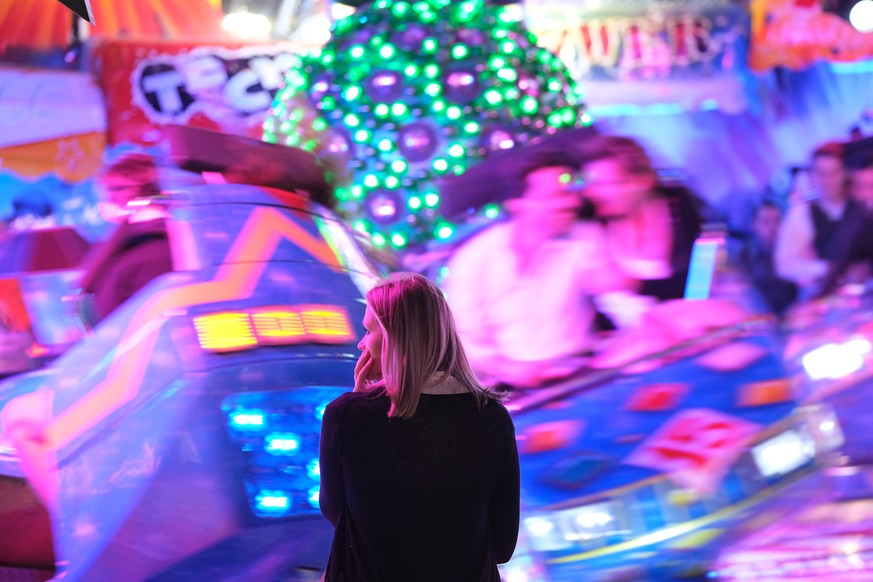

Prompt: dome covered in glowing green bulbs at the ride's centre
[{"left": 264, "top": 0, "right": 591, "bottom": 249}]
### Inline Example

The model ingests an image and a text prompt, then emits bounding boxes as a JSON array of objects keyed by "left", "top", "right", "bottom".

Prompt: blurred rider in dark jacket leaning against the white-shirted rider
[{"left": 582, "top": 136, "right": 701, "bottom": 328}]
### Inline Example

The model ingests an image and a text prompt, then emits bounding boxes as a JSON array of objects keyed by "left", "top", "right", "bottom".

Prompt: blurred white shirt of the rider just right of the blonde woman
[{"left": 445, "top": 222, "right": 614, "bottom": 367}]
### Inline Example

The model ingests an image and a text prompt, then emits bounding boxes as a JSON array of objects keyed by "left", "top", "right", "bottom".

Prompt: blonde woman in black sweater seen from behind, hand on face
[{"left": 319, "top": 273, "right": 520, "bottom": 582}]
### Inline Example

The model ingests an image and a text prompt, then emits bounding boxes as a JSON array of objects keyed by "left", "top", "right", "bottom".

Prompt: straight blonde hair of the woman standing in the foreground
[{"left": 367, "top": 273, "right": 501, "bottom": 418}]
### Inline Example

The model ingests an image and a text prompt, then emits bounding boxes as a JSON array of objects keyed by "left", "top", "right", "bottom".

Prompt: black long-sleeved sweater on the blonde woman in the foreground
[{"left": 320, "top": 390, "right": 519, "bottom": 582}]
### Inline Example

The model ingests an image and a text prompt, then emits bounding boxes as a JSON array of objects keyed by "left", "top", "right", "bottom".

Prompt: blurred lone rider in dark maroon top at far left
[{"left": 80, "top": 153, "right": 173, "bottom": 324}]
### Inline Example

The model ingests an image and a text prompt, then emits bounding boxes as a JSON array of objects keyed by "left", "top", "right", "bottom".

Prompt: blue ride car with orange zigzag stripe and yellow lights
[{"left": 0, "top": 136, "right": 377, "bottom": 582}]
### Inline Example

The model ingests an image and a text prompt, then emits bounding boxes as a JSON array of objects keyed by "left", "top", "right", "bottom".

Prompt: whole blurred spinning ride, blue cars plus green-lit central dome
[{"left": 0, "top": 0, "right": 873, "bottom": 582}]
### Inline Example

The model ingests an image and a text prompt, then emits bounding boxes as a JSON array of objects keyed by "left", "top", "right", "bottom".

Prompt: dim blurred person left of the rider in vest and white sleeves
[{"left": 736, "top": 200, "right": 797, "bottom": 317}]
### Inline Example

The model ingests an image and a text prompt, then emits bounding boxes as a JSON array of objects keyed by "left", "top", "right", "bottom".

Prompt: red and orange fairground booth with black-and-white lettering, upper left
[{"left": 0, "top": 0, "right": 310, "bottom": 240}]
